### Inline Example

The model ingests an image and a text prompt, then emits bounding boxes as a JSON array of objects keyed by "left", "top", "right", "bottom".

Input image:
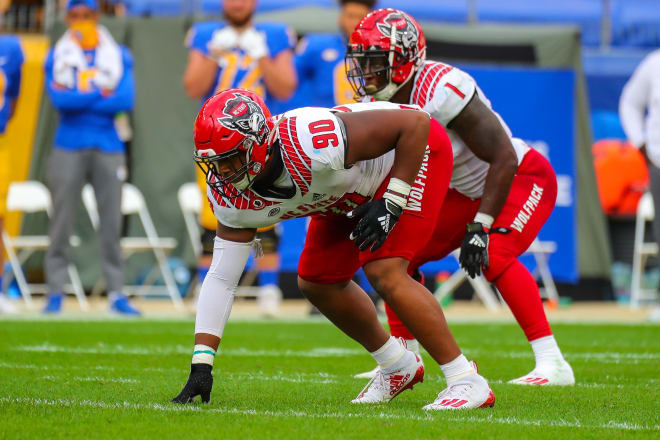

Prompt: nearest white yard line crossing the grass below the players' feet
[{"left": 0, "top": 397, "right": 660, "bottom": 431}]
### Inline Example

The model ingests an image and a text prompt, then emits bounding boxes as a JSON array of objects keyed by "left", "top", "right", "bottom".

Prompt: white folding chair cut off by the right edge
[{"left": 630, "top": 192, "right": 658, "bottom": 309}]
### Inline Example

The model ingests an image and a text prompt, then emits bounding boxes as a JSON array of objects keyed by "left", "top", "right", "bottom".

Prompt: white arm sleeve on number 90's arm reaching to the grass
[{"left": 195, "top": 237, "right": 254, "bottom": 338}]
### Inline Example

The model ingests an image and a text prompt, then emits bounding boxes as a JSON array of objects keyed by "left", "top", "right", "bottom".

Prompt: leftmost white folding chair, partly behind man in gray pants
[{"left": 2, "top": 181, "right": 89, "bottom": 310}]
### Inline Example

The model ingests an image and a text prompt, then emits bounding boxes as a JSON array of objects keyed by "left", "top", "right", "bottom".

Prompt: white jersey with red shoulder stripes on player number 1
[{"left": 410, "top": 61, "right": 529, "bottom": 199}]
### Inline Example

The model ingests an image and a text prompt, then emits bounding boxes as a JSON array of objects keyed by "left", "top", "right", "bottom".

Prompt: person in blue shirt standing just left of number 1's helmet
[{"left": 288, "top": 0, "right": 376, "bottom": 108}]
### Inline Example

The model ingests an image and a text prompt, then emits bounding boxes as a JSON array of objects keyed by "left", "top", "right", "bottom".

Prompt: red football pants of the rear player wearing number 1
[{"left": 386, "top": 150, "right": 557, "bottom": 341}]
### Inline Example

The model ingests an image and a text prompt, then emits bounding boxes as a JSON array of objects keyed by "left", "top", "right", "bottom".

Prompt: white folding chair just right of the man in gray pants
[{"left": 82, "top": 183, "right": 183, "bottom": 310}]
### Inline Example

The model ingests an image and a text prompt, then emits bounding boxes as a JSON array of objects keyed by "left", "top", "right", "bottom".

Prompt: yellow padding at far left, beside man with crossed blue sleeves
[{"left": 4, "top": 35, "right": 49, "bottom": 239}]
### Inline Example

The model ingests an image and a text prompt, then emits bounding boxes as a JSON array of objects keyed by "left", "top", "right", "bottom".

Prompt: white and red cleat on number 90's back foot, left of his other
[{"left": 351, "top": 350, "right": 424, "bottom": 403}]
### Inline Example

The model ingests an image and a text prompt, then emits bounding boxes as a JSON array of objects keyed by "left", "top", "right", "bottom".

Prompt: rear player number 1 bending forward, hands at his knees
[{"left": 347, "top": 9, "right": 575, "bottom": 385}]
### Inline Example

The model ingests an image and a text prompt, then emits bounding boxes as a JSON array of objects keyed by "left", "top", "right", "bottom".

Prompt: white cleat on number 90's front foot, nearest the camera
[{"left": 423, "top": 362, "right": 495, "bottom": 411}]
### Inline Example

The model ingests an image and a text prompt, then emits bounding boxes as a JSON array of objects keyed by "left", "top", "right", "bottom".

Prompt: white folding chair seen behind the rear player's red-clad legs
[{"left": 433, "top": 238, "right": 559, "bottom": 310}]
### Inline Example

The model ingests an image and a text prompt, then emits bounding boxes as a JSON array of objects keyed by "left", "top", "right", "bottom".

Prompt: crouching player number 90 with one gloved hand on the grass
[{"left": 173, "top": 90, "right": 495, "bottom": 409}]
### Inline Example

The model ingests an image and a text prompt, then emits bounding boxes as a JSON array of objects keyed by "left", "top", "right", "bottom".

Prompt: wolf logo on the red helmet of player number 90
[{"left": 217, "top": 93, "right": 269, "bottom": 144}]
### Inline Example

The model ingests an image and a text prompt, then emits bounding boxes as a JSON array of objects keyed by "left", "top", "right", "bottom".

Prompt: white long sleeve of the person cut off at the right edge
[{"left": 619, "top": 56, "right": 660, "bottom": 148}]
